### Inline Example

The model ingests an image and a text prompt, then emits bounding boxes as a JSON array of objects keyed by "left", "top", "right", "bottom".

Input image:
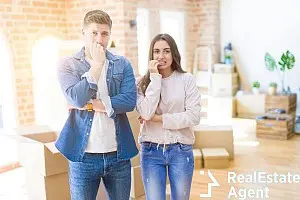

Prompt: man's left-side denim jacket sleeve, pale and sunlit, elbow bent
[{"left": 58, "top": 58, "right": 97, "bottom": 108}]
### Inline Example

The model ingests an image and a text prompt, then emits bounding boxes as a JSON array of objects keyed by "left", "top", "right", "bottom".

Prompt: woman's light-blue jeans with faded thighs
[{"left": 141, "top": 142, "right": 194, "bottom": 200}]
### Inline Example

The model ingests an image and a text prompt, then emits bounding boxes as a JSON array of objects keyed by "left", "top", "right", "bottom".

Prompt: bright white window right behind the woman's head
[{"left": 160, "top": 11, "right": 186, "bottom": 69}]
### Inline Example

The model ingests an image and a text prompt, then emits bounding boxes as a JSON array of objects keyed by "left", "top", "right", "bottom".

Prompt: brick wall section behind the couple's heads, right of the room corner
[{"left": 67, "top": 0, "right": 220, "bottom": 73}]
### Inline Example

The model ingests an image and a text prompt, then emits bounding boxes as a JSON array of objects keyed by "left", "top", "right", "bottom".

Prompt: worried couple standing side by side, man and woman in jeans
[{"left": 56, "top": 10, "right": 200, "bottom": 200}]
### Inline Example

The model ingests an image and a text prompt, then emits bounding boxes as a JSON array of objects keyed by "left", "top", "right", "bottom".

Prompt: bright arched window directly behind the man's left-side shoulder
[{"left": 32, "top": 36, "right": 82, "bottom": 130}]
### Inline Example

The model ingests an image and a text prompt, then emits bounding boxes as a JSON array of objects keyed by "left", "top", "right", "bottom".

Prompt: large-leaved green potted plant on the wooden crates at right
[{"left": 265, "top": 50, "right": 296, "bottom": 94}]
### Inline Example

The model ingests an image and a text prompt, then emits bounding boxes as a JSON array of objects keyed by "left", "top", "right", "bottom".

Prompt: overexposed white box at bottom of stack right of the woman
[{"left": 207, "top": 97, "right": 236, "bottom": 125}]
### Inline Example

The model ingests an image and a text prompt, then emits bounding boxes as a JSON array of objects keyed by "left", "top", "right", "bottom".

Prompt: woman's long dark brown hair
[{"left": 137, "top": 33, "right": 185, "bottom": 95}]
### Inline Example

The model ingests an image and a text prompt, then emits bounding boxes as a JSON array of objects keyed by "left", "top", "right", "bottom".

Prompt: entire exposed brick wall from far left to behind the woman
[{"left": 0, "top": 0, "right": 220, "bottom": 125}]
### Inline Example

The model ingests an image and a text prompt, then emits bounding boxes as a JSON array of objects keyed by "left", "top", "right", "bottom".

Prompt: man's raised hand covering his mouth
[{"left": 89, "top": 42, "right": 106, "bottom": 81}]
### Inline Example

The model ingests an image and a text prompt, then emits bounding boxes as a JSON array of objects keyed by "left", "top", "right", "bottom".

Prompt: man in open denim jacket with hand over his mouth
[{"left": 56, "top": 10, "right": 138, "bottom": 200}]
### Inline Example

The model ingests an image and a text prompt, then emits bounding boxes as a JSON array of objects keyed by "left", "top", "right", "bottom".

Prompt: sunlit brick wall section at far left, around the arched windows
[{"left": 0, "top": 0, "right": 67, "bottom": 125}]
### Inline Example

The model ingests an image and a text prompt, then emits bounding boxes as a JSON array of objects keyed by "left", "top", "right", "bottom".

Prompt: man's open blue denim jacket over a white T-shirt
[{"left": 55, "top": 48, "right": 138, "bottom": 162}]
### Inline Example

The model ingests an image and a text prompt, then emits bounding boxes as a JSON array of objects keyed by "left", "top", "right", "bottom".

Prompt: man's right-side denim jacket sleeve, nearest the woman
[{"left": 109, "top": 60, "right": 137, "bottom": 118}]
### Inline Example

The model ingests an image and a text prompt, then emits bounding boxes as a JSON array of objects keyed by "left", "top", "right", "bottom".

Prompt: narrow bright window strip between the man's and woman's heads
[{"left": 136, "top": 8, "right": 150, "bottom": 75}]
